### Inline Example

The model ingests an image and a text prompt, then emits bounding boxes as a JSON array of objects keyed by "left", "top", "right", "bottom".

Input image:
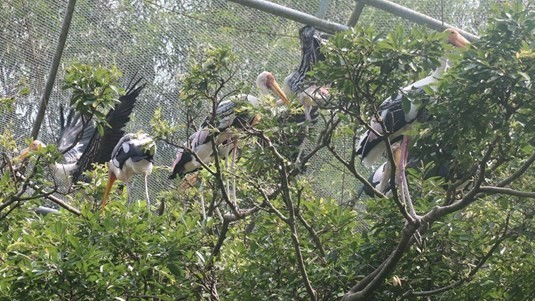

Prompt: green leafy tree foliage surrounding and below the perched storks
[{"left": 0, "top": 2, "right": 535, "bottom": 300}]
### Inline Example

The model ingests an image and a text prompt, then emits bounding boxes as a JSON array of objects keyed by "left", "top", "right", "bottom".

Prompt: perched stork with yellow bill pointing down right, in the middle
[{"left": 169, "top": 71, "right": 289, "bottom": 179}]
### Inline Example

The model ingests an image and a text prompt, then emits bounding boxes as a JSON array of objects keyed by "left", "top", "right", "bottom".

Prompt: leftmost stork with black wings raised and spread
[{"left": 19, "top": 79, "right": 145, "bottom": 186}]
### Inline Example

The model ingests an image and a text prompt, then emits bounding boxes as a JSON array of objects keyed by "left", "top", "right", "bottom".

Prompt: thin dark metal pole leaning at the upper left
[{"left": 32, "top": 0, "right": 76, "bottom": 140}]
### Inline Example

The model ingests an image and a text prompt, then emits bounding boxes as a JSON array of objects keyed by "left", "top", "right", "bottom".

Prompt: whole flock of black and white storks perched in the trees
[{"left": 14, "top": 26, "right": 468, "bottom": 210}]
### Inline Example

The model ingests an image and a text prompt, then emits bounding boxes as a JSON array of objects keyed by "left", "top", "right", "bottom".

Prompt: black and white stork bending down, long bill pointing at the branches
[{"left": 101, "top": 133, "right": 156, "bottom": 210}]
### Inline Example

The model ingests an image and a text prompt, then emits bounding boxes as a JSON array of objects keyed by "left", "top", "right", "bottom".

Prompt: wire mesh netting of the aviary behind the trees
[{"left": 0, "top": 0, "right": 493, "bottom": 201}]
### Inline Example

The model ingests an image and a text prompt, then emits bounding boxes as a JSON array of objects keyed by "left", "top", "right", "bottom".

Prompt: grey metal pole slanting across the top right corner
[{"left": 357, "top": 0, "right": 479, "bottom": 42}]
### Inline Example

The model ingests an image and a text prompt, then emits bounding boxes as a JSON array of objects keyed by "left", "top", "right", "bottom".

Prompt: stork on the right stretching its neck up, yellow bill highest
[{"left": 357, "top": 28, "right": 470, "bottom": 167}]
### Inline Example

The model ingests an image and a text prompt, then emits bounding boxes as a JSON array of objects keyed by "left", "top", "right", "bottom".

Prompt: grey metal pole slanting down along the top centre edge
[{"left": 229, "top": 0, "right": 349, "bottom": 33}]
